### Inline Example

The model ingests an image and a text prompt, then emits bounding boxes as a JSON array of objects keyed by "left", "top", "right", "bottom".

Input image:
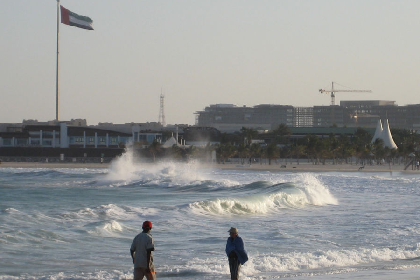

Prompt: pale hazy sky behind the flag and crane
[{"left": 0, "top": 0, "right": 420, "bottom": 125}]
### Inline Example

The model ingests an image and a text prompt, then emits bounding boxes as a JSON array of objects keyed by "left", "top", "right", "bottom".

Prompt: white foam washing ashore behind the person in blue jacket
[{"left": 140, "top": 245, "right": 420, "bottom": 279}]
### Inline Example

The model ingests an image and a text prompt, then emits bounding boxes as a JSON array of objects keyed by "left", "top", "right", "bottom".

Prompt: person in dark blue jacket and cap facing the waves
[{"left": 226, "top": 227, "right": 248, "bottom": 280}]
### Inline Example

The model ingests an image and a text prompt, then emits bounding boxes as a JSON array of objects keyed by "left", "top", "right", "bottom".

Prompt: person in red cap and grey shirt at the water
[{"left": 130, "top": 221, "right": 156, "bottom": 280}]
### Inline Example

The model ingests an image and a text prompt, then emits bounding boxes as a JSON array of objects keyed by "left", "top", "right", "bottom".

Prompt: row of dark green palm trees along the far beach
[{"left": 136, "top": 124, "right": 420, "bottom": 164}]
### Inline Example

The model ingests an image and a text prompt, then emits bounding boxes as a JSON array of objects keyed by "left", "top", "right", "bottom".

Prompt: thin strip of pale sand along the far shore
[{"left": 0, "top": 162, "right": 420, "bottom": 174}]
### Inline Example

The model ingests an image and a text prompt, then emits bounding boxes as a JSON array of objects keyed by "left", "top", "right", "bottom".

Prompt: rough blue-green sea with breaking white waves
[{"left": 0, "top": 150, "right": 420, "bottom": 280}]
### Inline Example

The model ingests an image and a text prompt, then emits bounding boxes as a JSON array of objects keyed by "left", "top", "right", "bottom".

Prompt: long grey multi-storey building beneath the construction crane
[{"left": 195, "top": 100, "right": 420, "bottom": 133}]
